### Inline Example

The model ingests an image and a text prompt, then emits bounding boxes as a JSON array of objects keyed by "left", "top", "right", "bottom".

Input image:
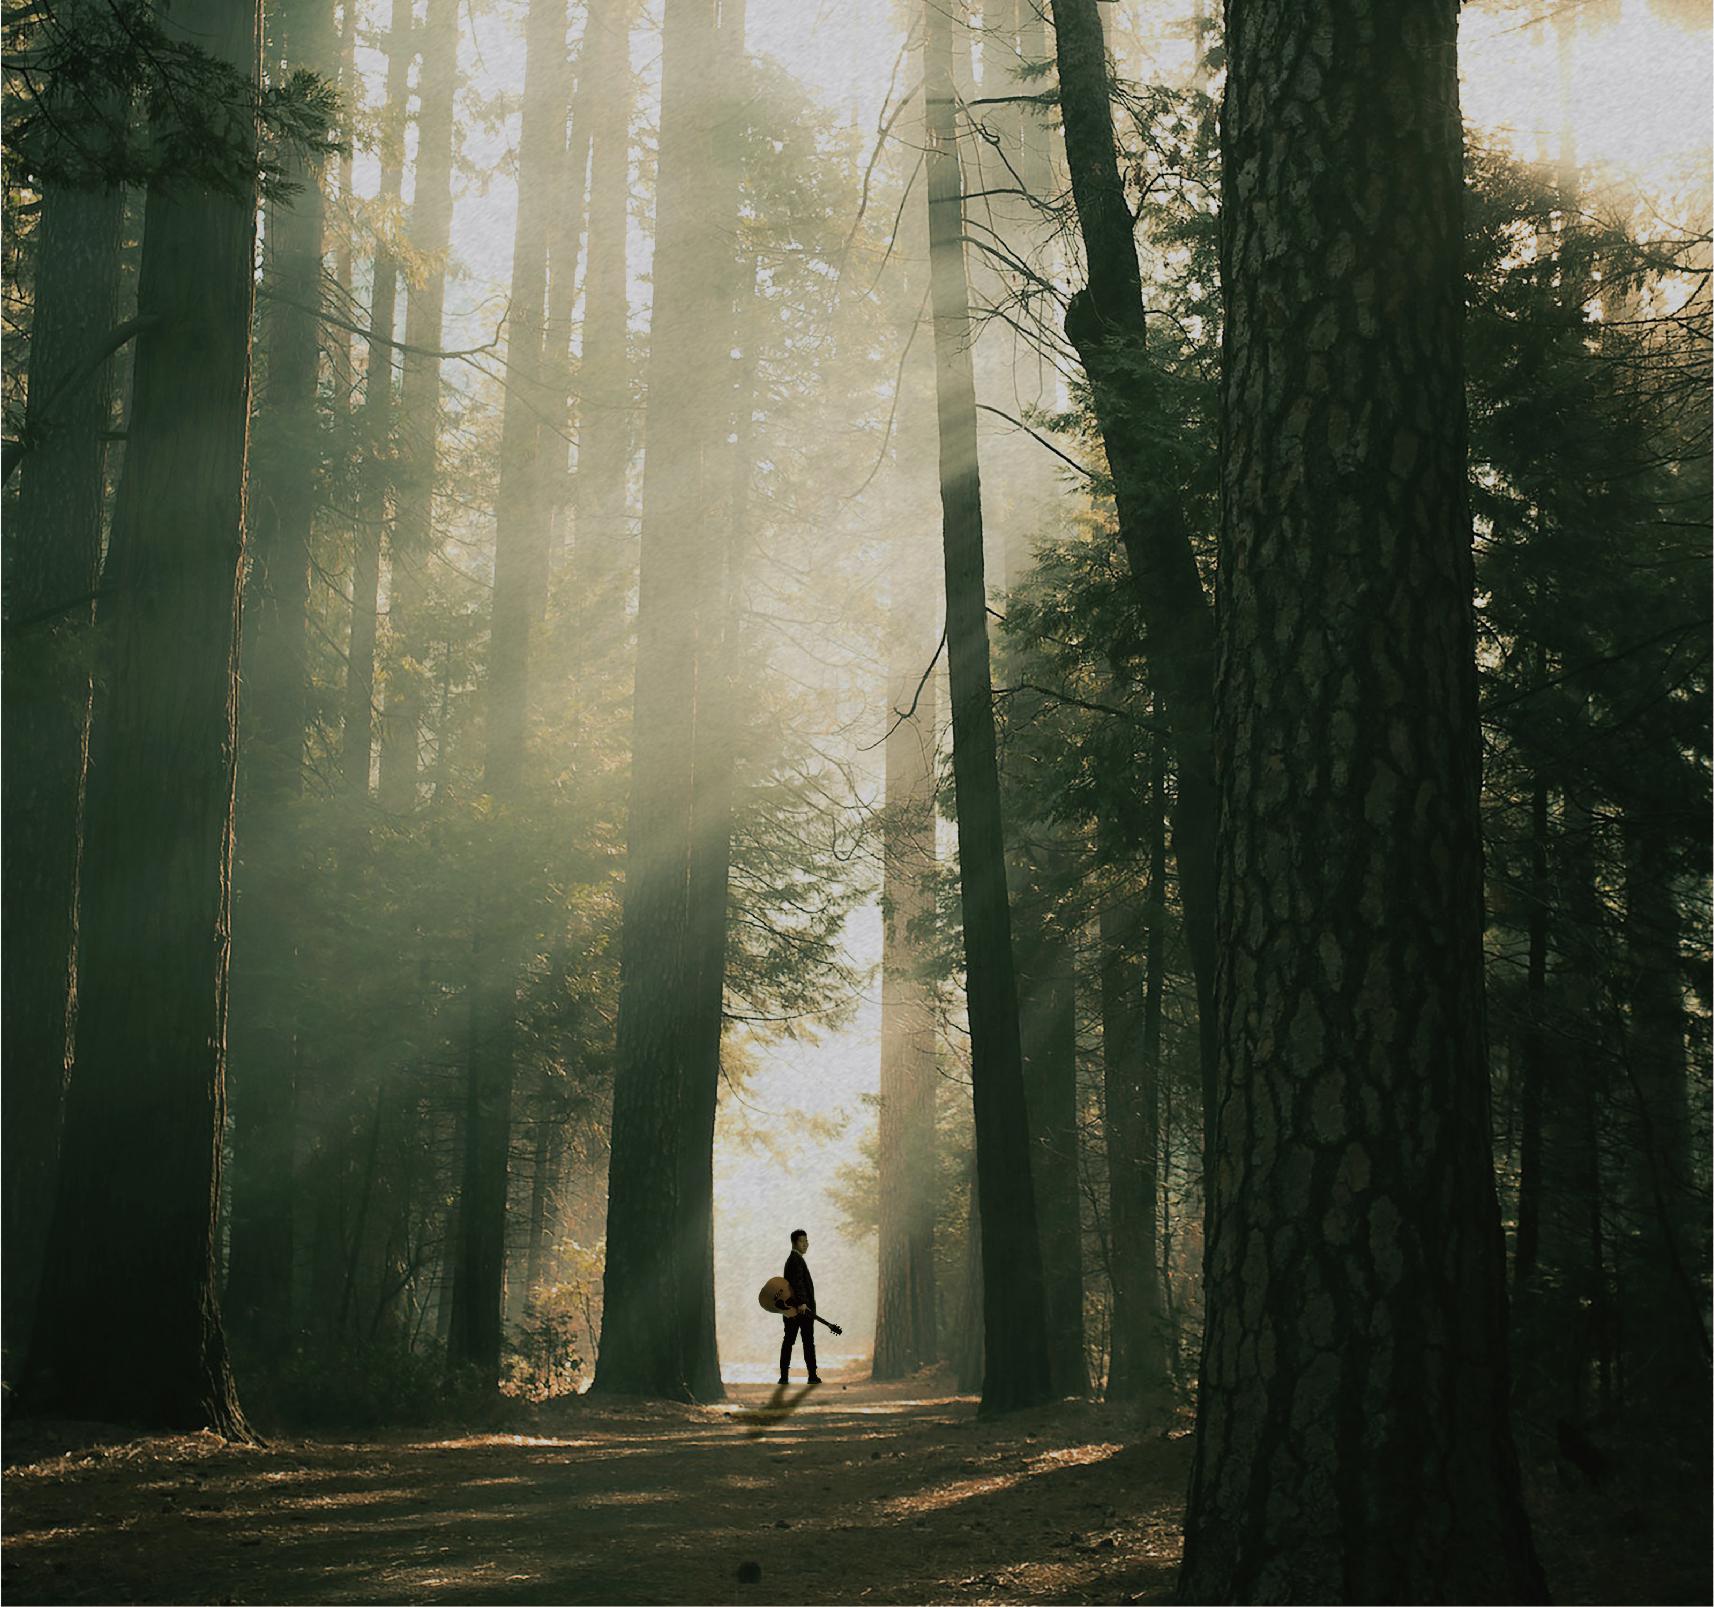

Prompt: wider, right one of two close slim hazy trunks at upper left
[{"left": 379, "top": 0, "right": 458, "bottom": 814}]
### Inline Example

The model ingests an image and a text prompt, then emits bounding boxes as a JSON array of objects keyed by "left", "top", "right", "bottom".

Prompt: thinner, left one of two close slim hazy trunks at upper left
[{"left": 341, "top": 0, "right": 417, "bottom": 798}]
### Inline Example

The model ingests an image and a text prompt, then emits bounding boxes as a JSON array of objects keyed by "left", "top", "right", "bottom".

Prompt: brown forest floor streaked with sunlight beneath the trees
[{"left": 0, "top": 1372, "right": 1707, "bottom": 1604}]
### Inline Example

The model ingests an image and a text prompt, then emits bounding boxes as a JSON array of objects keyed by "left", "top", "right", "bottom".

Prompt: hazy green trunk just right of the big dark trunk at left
[{"left": 225, "top": 0, "right": 336, "bottom": 1355}]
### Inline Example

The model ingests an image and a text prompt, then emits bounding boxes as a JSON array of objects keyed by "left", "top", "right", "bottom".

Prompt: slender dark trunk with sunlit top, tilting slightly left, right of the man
[{"left": 924, "top": 0, "right": 1051, "bottom": 1412}]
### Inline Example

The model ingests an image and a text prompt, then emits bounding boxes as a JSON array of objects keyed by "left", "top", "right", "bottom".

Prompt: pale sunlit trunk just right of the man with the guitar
[{"left": 872, "top": 603, "right": 939, "bottom": 1379}]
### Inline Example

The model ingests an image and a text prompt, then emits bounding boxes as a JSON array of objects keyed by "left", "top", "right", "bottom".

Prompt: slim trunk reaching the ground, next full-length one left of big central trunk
[{"left": 452, "top": 0, "right": 566, "bottom": 1377}]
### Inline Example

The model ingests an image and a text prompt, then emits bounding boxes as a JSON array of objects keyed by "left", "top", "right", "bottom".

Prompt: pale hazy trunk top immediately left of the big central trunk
[{"left": 572, "top": 0, "right": 636, "bottom": 630}]
